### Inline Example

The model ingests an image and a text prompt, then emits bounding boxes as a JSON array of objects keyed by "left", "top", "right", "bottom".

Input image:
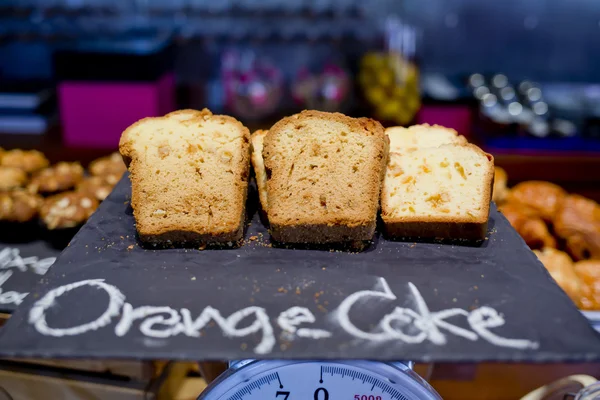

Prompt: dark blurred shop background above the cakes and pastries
[{"left": 0, "top": 0, "right": 600, "bottom": 200}]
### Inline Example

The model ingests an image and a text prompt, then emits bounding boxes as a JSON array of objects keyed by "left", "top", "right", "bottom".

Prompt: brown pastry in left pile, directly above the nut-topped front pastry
[{"left": 27, "top": 162, "right": 83, "bottom": 194}]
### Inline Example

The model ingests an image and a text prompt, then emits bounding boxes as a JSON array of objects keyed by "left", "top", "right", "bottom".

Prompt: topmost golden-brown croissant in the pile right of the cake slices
[{"left": 507, "top": 181, "right": 567, "bottom": 222}]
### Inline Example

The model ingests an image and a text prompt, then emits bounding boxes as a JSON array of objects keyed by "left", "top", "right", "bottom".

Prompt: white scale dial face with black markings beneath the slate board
[{"left": 200, "top": 361, "right": 441, "bottom": 400}]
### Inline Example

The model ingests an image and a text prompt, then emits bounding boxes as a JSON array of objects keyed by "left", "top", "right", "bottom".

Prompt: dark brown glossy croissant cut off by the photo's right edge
[{"left": 554, "top": 195, "right": 600, "bottom": 261}]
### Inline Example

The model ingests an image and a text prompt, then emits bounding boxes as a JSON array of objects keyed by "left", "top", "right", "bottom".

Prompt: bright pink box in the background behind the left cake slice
[{"left": 58, "top": 73, "right": 176, "bottom": 149}]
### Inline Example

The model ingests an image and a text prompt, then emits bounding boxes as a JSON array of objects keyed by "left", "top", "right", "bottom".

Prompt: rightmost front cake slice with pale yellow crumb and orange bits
[{"left": 381, "top": 139, "right": 494, "bottom": 240}]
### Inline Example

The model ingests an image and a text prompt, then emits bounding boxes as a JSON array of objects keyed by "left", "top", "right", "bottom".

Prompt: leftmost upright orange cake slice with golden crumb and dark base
[{"left": 119, "top": 109, "right": 250, "bottom": 245}]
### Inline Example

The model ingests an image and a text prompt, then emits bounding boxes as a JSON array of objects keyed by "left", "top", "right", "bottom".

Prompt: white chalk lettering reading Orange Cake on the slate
[{"left": 28, "top": 271, "right": 539, "bottom": 354}]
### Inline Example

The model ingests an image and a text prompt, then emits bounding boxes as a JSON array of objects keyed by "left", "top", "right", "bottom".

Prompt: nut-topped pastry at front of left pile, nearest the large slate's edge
[{"left": 40, "top": 192, "right": 98, "bottom": 230}]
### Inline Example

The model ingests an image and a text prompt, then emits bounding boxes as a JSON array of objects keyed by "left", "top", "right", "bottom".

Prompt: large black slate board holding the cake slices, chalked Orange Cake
[{"left": 0, "top": 178, "right": 600, "bottom": 362}]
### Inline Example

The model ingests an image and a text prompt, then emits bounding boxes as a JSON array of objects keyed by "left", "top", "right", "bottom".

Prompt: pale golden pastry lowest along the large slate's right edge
[{"left": 533, "top": 248, "right": 589, "bottom": 307}]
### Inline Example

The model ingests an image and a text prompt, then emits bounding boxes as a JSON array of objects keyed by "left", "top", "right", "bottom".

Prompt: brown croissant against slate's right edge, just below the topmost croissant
[{"left": 498, "top": 203, "right": 556, "bottom": 249}]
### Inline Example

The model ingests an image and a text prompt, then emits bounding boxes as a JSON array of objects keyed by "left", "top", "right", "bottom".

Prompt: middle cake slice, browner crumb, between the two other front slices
[{"left": 254, "top": 111, "right": 388, "bottom": 244}]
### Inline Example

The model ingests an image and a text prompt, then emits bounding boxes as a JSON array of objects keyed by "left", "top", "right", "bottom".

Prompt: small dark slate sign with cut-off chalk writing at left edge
[{"left": 0, "top": 238, "right": 60, "bottom": 313}]
